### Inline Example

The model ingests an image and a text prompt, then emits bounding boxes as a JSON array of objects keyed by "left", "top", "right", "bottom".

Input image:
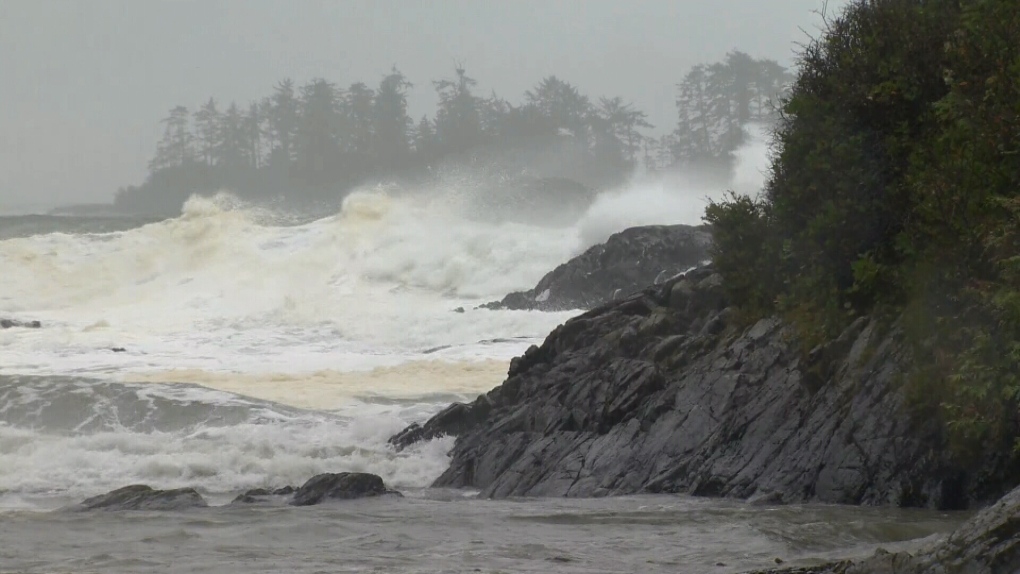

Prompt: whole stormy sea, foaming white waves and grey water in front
[{"left": 0, "top": 136, "right": 964, "bottom": 573}]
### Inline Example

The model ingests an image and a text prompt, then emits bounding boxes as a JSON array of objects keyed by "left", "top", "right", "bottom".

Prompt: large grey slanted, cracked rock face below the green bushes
[{"left": 392, "top": 267, "right": 1004, "bottom": 509}]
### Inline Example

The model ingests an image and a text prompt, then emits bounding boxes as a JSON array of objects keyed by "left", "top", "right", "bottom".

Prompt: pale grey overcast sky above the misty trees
[{"left": 0, "top": 0, "right": 843, "bottom": 207}]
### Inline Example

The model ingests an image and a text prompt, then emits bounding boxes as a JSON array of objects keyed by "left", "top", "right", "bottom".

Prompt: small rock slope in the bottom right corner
[{"left": 751, "top": 488, "right": 1020, "bottom": 574}]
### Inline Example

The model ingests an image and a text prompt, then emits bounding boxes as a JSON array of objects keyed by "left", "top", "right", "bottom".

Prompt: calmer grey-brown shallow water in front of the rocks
[{"left": 0, "top": 490, "right": 962, "bottom": 574}]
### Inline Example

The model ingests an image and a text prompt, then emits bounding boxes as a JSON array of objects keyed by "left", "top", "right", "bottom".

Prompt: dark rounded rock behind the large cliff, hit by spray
[{"left": 486, "top": 225, "right": 712, "bottom": 311}]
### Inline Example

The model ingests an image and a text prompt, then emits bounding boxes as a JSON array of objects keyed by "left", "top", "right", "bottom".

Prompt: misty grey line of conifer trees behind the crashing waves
[{"left": 115, "top": 51, "right": 792, "bottom": 215}]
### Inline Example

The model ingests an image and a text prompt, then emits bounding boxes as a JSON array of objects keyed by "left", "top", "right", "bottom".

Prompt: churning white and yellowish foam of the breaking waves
[{"left": 0, "top": 132, "right": 762, "bottom": 507}]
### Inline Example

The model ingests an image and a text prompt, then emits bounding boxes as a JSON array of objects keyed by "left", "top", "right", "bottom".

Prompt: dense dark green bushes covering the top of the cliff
[{"left": 706, "top": 0, "right": 1020, "bottom": 466}]
